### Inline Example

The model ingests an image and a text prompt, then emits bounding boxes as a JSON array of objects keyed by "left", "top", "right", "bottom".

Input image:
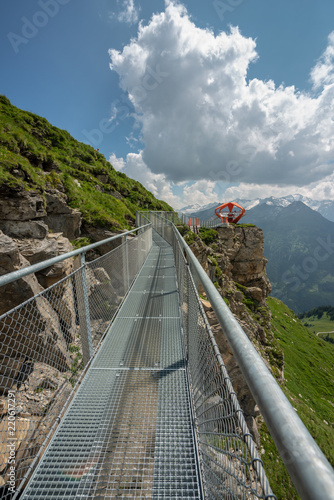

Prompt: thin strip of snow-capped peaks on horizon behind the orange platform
[{"left": 180, "top": 194, "right": 334, "bottom": 222}]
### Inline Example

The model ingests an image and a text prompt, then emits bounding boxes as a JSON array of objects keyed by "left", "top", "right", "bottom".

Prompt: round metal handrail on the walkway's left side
[{"left": 0, "top": 224, "right": 152, "bottom": 287}]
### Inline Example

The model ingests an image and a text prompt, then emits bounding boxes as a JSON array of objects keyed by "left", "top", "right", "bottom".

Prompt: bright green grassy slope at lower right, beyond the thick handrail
[{"left": 261, "top": 298, "right": 334, "bottom": 500}]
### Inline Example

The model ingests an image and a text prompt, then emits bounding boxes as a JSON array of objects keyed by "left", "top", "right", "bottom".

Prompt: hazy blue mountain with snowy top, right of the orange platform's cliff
[{"left": 183, "top": 196, "right": 334, "bottom": 312}]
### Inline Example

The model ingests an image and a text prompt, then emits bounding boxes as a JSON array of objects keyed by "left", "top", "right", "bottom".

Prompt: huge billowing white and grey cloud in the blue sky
[{"left": 109, "top": 0, "right": 334, "bottom": 203}]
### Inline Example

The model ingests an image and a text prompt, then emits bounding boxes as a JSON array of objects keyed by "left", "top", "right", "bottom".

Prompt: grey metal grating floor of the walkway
[{"left": 22, "top": 233, "right": 202, "bottom": 500}]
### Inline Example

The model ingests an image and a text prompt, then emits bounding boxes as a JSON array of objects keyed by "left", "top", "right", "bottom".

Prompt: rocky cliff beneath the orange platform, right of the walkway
[{"left": 185, "top": 225, "right": 284, "bottom": 440}]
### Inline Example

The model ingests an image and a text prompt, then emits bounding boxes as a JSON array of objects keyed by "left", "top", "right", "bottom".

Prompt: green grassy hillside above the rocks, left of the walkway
[{"left": 0, "top": 96, "right": 171, "bottom": 229}]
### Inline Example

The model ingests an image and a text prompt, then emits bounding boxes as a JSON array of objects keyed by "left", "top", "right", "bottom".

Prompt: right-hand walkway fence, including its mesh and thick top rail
[{"left": 138, "top": 212, "right": 334, "bottom": 500}]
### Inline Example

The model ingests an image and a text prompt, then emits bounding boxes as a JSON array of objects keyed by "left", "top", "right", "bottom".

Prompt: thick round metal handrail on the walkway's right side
[{"left": 154, "top": 212, "right": 334, "bottom": 500}]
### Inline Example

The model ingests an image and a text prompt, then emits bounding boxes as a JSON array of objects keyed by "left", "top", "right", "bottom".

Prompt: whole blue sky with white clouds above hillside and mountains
[{"left": 0, "top": 0, "right": 334, "bottom": 208}]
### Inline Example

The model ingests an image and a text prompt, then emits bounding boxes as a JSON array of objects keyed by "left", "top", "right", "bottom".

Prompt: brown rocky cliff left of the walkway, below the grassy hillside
[{"left": 0, "top": 185, "right": 127, "bottom": 490}]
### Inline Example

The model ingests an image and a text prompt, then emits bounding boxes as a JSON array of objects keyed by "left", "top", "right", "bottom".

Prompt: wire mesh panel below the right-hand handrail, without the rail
[{"left": 145, "top": 212, "right": 276, "bottom": 500}]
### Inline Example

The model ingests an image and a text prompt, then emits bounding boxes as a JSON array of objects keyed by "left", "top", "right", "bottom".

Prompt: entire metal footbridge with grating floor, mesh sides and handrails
[{"left": 0, "top": 212, "right": 334, "bottom": 500}]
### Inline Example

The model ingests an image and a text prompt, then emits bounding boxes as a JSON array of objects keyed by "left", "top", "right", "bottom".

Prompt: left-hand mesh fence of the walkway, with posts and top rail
[{"left": 0, "top": 225, "right": 152, "bottom": 499}]
